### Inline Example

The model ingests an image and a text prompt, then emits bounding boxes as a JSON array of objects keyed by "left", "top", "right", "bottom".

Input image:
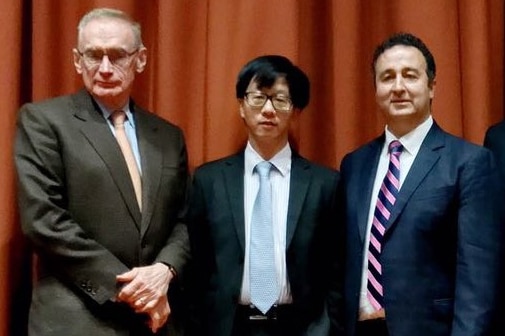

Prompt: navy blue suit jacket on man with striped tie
[{"left": 341, "top": 124, "right": 505, "bottom": 336}]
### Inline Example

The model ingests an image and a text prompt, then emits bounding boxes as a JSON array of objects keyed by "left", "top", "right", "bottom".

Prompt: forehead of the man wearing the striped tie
[{"left": 375, "top": 45, "right": 427, "bottom": 73}]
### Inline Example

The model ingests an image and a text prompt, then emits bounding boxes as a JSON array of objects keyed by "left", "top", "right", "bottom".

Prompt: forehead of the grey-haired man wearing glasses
[{"left": 79, "top": 18, "right": 135, "bottom": 49}]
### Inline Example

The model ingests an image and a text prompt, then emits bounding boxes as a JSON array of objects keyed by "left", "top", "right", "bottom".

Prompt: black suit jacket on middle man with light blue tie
[{"left": 188, "top": 152, "right": 341, "bottom": 336}]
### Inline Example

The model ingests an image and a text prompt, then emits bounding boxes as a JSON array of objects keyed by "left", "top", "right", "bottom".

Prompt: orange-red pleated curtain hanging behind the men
[{"left": 0, "top": 0, "right": 505, "bottom": 335}]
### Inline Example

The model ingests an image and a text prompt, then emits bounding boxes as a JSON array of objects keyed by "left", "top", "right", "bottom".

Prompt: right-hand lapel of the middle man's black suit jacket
[{"left": 286, "top": 153, "right": 311, "bottom": 249}]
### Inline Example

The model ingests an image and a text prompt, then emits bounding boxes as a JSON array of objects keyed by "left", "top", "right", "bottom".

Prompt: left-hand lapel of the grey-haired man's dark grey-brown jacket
[{"left": 74, "top": 90, "right": 141, "bottom": 227}]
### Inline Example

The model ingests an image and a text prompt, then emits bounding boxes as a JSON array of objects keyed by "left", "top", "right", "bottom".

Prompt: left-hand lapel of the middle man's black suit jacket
[{"left": 222, "top": 152, "right": 245, "bottom": 252}]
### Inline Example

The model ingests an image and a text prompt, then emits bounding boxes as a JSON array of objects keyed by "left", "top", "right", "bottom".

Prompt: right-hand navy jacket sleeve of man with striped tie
[{"left": 452, "top": 150, "right": 505, "bottom": 335}]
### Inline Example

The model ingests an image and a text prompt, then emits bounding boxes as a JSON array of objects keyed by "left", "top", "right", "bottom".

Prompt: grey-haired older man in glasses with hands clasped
[{"left": 15, "top": 9, "right": 189, "bottom": 336}]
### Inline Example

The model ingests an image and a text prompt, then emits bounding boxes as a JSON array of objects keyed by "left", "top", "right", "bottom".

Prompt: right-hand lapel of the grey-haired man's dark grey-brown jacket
[{"left": 131, "top": 104, "right": 163, "bottom": 235}]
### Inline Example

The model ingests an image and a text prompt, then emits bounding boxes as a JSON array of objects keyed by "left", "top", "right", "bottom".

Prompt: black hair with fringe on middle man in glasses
[{"left": 235, "top": 55, "right": 310, "bottom": 109}]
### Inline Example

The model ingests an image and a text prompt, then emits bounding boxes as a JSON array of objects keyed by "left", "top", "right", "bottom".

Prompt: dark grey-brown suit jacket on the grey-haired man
[{"left": 15, "top": 90, "right": 189, "bottom": 336}]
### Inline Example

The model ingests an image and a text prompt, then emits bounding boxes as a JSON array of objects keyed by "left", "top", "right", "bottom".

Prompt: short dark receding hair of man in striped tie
[{"left": 372, "top": 32, "right": 437, "bottom": 84}]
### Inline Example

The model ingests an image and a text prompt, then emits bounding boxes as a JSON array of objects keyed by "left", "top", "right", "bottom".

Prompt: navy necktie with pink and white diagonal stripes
[{"left": 367, "top": 140, "right": 403, "bottom": 310}]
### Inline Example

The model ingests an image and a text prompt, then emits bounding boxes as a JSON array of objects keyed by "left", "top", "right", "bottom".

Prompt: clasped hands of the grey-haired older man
[{"left": 116, "top": 263, "right": 173, "bottom": 333}]
